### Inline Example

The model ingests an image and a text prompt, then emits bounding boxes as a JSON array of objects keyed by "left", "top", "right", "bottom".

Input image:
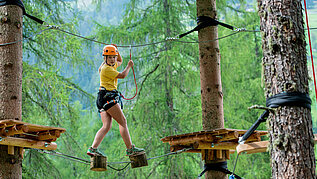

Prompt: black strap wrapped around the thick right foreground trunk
[{"left": 239, "top": 92, "right": 311, "bottom": 143}]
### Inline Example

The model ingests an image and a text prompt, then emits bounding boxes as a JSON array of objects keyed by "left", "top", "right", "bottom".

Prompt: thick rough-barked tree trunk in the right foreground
[{"left": 258, "top": 0, "right": 316, "bottom": 179}]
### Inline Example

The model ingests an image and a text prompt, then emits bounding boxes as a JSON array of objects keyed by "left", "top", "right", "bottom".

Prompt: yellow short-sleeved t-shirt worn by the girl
[{"left": 100, "top": 62, "right": 119, "bottom": 91}]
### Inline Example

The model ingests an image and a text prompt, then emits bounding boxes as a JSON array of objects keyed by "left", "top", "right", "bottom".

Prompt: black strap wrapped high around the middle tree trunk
[{"left": 178, "top": 16, "right": 234, "bottom": 38}]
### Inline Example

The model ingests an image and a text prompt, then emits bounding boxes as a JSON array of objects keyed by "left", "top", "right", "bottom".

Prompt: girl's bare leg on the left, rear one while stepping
[{"left": 91, "top": 111, "right": 112, "bottom": 149}]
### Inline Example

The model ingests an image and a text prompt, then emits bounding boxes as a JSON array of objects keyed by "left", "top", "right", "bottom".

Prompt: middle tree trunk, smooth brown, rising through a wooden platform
[{"left": 196, "top": 0, "right": 227, "bottom": 179}]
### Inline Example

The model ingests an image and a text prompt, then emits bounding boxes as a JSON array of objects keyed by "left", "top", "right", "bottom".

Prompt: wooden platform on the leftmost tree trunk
[{"left": 0, "top": 119, "right": 66, "bottom": 150}]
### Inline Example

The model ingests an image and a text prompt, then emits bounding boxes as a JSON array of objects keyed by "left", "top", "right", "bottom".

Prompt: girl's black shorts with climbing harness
[{"left": 96, "top": 90, "right": 122, "bottom": 113}]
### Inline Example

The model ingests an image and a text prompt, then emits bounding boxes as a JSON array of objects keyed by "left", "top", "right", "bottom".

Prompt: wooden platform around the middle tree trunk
[{"left": 161, "top": 128, "right": 268, "bottom": 160}]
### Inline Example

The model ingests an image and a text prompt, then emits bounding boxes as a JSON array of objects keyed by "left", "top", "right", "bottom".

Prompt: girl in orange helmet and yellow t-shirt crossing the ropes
[{"left": 87, "top": 45, "right": 144, "bottom": 156}]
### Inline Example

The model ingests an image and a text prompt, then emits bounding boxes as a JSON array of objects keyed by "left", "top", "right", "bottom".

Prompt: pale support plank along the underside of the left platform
[{"left": 0, "top": 137, "right": 57, "bottom": 150}]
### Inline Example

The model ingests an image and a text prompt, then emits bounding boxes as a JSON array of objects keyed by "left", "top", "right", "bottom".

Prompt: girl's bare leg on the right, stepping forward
[{"left": 107, "top": 104, "right": 132, "bottom": 149}]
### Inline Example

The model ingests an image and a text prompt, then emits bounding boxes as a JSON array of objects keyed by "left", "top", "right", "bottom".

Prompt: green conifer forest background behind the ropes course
[{"left": 22, "top": 0, "right": 317, "bottom": 179}]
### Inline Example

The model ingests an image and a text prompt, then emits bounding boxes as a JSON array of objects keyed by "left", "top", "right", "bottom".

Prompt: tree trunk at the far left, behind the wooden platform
[{"left": 0, "top": 5, "right": 22, "bottom": 179}]
